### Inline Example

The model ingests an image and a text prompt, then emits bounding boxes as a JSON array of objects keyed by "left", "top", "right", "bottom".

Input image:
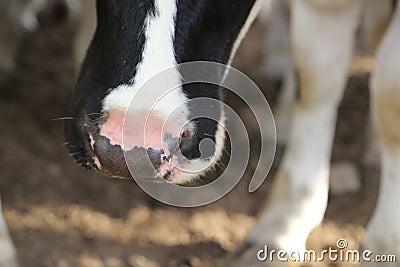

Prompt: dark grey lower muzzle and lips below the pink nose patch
[{"left": 67, "top": 113, "right": 188, "bottom": 183}]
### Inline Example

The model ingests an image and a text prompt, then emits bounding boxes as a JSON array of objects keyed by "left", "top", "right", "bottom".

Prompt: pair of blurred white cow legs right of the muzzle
[{"left": 237, "top": 0, "right": 400, "bottom": 266}]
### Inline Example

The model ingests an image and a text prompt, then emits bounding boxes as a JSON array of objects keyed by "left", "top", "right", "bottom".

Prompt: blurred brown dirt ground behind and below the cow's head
[{"left": 0, "top": 9, "right": 379, "bottom": 267}]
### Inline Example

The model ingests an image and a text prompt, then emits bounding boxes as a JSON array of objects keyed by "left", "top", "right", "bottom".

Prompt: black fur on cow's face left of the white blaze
[{"left": 65, "top": 0, "right": 155, "bottom": 172}]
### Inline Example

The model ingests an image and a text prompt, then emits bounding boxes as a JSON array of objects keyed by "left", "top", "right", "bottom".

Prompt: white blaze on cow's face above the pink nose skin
[{"left": 103, "top": 0, "right": 187, "bottom": 123}]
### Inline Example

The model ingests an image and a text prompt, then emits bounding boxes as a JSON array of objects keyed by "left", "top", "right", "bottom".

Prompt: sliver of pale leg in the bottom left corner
[{"left": 0, "top": 201, "right": 18, "bottom": 267}]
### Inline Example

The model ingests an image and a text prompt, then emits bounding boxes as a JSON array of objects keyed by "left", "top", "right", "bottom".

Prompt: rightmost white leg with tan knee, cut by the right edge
[{"left": 364, "top": 5, "right": 400, "bottom": 266}]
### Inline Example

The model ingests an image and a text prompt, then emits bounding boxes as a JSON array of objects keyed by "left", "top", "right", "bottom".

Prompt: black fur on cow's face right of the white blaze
[{"left": 174, "top": 0, "right": 255, "bottom": 158}]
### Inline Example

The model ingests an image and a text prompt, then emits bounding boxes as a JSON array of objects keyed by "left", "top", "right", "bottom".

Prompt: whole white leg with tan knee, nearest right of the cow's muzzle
[{"left": 233, "top": 0, "right": 360, "bottom": 266}]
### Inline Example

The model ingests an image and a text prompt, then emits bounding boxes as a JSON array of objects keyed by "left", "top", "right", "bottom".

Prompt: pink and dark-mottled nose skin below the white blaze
[{"left": 96, "top": 109, "right": 184, "bottom": 181}]
